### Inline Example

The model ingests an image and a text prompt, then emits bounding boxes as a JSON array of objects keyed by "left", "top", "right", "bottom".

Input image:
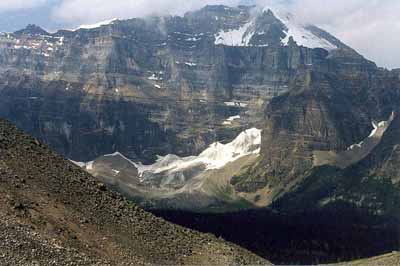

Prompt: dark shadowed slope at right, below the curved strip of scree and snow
[{"left": 272, "top": 98, "right": 400, "bottom": 216}]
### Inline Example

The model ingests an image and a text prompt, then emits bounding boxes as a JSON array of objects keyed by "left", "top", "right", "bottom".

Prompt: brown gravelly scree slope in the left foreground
[{"left": 0, "top": 120, "right": 267, "bottom": 265}]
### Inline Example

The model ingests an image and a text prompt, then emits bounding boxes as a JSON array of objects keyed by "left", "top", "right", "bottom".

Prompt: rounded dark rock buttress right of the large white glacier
[{"left": 233, "top": 50, "right": 400, "bottom": 205}]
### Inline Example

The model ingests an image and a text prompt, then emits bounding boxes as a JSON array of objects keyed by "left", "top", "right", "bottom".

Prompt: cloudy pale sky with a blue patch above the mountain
[{"left": 0, "top": 0, "right": 400, "bottom": 68}]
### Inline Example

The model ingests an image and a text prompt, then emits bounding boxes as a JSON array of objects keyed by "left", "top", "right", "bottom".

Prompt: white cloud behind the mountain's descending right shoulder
[{"left": 289, "top": 0, "right": 400, "bottom": 68}]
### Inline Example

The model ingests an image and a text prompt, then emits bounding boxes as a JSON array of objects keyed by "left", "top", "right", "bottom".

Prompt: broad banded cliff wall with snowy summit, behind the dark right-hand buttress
[{"left": 0, "top": 6, "right": 353, "bottom": 161}]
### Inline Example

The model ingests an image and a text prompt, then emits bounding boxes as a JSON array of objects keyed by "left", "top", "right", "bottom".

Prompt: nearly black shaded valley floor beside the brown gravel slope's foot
[{"left": 153, "top": 206, "right": 400, "bottom": 265}]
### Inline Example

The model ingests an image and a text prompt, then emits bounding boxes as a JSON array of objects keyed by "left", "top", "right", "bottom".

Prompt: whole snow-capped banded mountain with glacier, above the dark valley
[{"left": 0, "top": 5, "right": 400, "bottom": 214}]
